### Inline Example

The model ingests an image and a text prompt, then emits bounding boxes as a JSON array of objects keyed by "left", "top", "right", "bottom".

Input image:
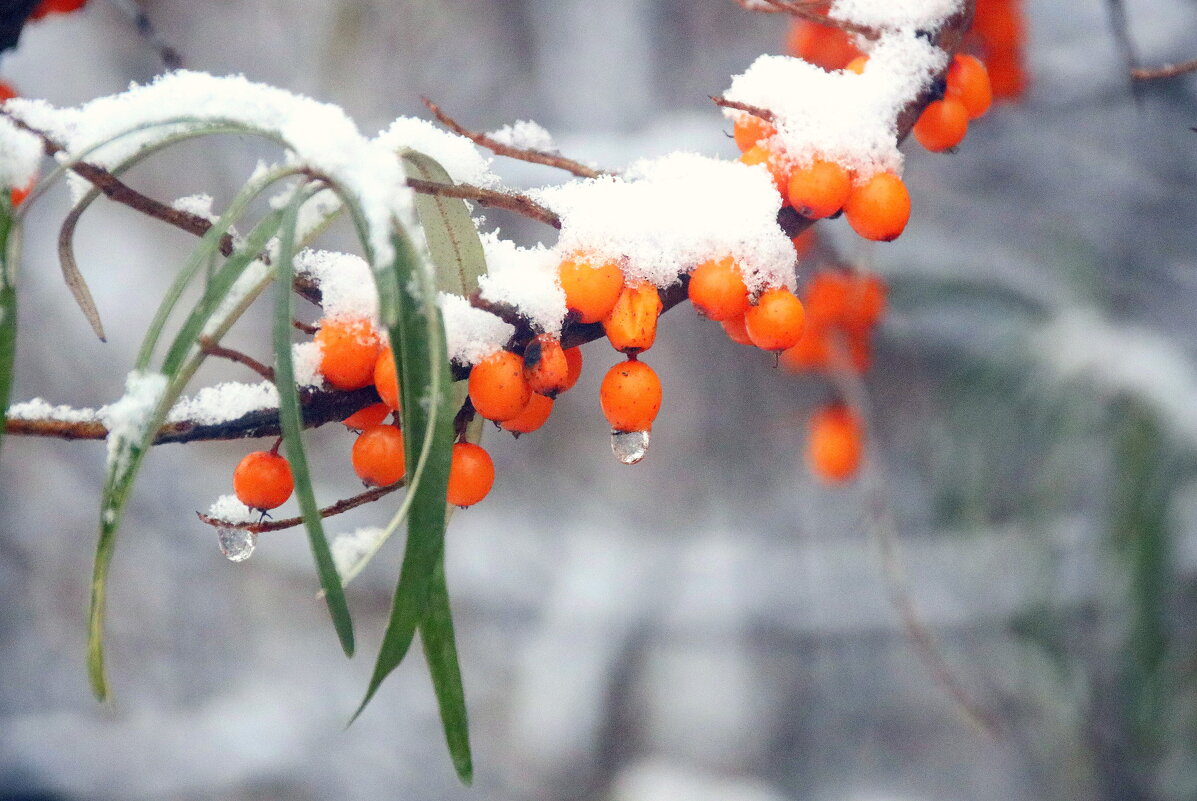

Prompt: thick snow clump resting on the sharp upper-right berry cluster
[{"left": 724, "top": 29, "right": 948, "bottom": 181}]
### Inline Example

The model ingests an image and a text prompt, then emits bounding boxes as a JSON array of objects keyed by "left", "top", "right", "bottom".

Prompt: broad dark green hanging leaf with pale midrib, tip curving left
[{"left": 353, "top": 226, "right": 455, "bottom": 718}]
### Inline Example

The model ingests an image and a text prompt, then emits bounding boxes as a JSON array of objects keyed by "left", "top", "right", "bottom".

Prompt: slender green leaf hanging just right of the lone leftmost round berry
[{"left": 274, "top": 192, "right": 353, "bottom": 656}]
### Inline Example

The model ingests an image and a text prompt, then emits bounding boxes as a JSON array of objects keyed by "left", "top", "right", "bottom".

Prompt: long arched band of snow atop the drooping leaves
[{"left": 7, "top": 71, "right": 418, "bottom": 265}]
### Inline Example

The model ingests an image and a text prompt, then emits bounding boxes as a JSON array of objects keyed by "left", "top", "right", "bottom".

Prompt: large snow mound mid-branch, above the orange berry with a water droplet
[{"left": 533, "top": 153, "right": 795, "bottom": 292}]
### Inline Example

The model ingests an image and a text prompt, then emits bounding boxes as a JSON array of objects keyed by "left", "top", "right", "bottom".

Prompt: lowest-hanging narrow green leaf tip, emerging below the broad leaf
[{"left": 420, "top": 554, "right": 474, "bottom": 784}]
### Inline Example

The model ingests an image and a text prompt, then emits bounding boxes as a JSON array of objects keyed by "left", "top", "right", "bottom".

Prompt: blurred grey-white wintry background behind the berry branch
[{"left": 0, "top": 0, "right": 1197, "bottom": 801}]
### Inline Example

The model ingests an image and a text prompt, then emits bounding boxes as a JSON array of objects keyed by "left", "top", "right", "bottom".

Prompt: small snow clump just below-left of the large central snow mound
[{"left": 476, "top": 233, "right": 566, "bottom": 336}]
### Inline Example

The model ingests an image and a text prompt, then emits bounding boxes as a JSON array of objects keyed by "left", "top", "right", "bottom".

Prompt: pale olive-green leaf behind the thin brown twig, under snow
[{"left": 401, "top": 150, "right": 486, "bottom": 297}]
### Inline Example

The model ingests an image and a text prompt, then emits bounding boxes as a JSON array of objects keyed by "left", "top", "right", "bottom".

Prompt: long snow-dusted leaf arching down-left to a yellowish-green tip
[{"left": 87, "top": 196, "right": 282, "bottom": 700}]
